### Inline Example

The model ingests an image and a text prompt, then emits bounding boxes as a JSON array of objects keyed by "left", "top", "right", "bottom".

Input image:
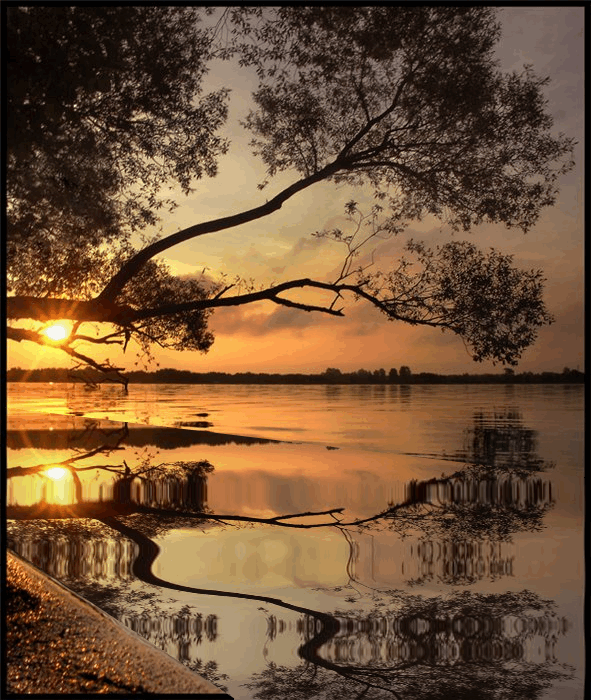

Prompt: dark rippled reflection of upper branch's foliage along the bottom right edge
[{"left": 247, "top": 591, "right": 572, "bottom": 700}]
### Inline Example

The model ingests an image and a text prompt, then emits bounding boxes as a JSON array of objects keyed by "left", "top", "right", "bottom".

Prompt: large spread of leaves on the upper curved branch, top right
[{"left": 234, "top": 6, "right": 572, "bottom": 231}]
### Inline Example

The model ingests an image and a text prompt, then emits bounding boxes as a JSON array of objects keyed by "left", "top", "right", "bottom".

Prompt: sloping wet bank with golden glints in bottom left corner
[{"left": 3, "top": 550, "right": 232, "bottom": 700}]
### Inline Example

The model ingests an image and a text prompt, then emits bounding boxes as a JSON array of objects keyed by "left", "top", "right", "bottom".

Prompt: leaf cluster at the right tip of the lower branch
[{"left": 361, "top": 241, "right": 553, "bottom": 364}]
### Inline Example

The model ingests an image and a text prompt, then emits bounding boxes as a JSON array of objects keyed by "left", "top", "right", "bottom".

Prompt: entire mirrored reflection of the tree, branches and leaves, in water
[{"left": 8, "top": 412, "right": 571, "bottom": 700}]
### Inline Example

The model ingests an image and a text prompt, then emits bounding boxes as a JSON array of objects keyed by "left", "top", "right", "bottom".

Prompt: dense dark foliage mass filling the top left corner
[{"left": 6, "top": 5, "right": 226, "bottom": 295}]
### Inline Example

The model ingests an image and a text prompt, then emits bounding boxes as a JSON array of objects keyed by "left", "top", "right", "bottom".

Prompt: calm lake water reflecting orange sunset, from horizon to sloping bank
[{"left": 6, "top": 384, "right": 584, "bottom": 700}]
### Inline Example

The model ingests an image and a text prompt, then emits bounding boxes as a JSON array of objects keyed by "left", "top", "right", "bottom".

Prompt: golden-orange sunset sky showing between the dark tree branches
[{"left": 8, "top": 6, "right": 584, "bottom": 373}]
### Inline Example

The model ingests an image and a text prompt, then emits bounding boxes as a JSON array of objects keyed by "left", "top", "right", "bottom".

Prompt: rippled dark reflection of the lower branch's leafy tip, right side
[{"left": 374, "top": 408, "right": 555, "bottom": 586}]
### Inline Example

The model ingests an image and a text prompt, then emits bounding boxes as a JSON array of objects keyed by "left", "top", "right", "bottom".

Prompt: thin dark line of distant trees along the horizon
[{"left": 6, "top": 365, "right": 585, "bottom": 384}]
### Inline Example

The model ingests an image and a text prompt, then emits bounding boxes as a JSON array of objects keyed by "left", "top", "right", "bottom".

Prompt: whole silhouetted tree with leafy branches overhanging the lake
[{"left": 7, "top": 6, "right": 573, "bottom": 382}]
